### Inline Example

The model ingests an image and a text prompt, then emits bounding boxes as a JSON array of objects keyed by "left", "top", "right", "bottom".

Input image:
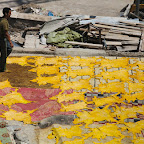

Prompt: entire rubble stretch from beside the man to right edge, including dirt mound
[{"left": 3, "top": 4, "right": 144, "bottom": 52}]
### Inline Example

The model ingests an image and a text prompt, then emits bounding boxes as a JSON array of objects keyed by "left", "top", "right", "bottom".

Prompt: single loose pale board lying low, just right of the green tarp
[{"left": 65, "top": 41, "right": 103, "bottom": 48}]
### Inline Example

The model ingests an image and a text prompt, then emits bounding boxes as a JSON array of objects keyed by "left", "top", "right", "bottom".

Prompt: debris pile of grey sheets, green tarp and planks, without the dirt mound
[{"left": 11, "top": 17, "right": 144, "bottom": 52}]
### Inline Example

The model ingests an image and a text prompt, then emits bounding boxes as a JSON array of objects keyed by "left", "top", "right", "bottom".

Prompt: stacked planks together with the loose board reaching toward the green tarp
[{"left": 71, "top": 21, "right": 144, "bottom": 52}]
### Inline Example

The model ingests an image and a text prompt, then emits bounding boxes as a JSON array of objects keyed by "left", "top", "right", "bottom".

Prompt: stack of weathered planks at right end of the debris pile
[{"left": 94, "top": 21, "right": 144, "bottom": 51}]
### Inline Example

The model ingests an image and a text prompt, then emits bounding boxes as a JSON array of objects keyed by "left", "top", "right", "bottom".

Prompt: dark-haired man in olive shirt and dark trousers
[{"left": 0, "top": 7, "right": 13, "bottom": 72}]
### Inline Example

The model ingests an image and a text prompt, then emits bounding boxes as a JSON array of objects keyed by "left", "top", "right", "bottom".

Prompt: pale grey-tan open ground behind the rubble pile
[{"left": 0, "top": 0, "right": 133, "bottom": 16}]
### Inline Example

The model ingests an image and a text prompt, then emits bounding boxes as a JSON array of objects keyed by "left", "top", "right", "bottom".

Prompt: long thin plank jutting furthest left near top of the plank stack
[{"left": 94, "top": 24, "right": 139, "bottom": 32}]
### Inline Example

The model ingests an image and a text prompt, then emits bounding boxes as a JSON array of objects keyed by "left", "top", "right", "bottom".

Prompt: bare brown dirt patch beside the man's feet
[{"left": 0, "top": 64, "right": 51, "bottom": 88}]
